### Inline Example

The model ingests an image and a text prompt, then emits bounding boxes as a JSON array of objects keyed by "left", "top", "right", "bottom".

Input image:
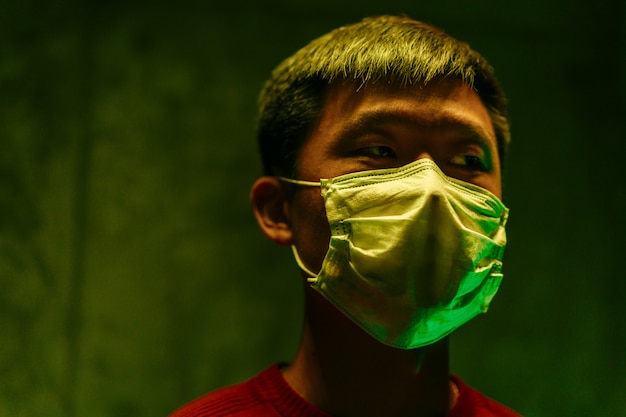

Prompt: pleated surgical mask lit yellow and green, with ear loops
[{"left": 283, "top": 159, "right": 508, "bottom": 349}]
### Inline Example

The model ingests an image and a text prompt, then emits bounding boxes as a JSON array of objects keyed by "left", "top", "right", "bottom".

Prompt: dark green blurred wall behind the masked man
[{"left": 0, "top": 0, "right": 626, "bottom": 417}]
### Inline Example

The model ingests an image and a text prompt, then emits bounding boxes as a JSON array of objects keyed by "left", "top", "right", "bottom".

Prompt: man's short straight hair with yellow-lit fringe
[{"left": 257, "top": 16, "right": 510, "bottom": 176}]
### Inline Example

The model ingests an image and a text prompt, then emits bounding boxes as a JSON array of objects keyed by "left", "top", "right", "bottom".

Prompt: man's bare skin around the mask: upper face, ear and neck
[{"left": 252, "top": 81, "right": 501, "bottom": 417}]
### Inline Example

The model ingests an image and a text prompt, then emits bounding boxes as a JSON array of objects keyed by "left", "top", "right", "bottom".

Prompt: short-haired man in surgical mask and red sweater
[{"left": 168, "top": 16, "right": 517, "bottom": 417}]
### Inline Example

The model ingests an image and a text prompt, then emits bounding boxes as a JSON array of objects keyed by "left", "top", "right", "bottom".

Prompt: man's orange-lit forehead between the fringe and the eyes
[{"left": 311, "top": 80, "right": 497, "bottom": 151}]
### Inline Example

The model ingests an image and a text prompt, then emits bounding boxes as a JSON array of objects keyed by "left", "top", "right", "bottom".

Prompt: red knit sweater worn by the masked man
[{"left": 170, "top": 365, "right": 520, "bottom": 417}]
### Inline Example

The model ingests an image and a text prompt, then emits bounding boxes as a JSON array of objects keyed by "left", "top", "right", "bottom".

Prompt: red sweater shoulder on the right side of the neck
[{"left": 448, "top": 375, "right": 521, "bottom": 417}]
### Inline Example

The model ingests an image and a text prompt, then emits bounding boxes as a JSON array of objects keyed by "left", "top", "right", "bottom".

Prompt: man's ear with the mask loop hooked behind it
[{"left": 250, "top": 177, "right": 293, "bottom": 245}]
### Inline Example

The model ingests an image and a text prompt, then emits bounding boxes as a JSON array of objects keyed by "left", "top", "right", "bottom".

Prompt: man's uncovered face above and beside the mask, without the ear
[{"left": 288, "top": 82, "right": 501, "bottom": 272}]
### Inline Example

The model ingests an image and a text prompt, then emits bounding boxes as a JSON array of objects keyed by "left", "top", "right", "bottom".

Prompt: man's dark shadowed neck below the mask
[{"left": 284, "top": 289, "right": 450, "bottom": 417}]
